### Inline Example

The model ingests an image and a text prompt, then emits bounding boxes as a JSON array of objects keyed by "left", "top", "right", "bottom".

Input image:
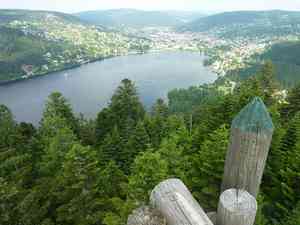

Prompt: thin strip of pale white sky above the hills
[{"left": 0, "top": 0, "right": 300, "bottom": 12}]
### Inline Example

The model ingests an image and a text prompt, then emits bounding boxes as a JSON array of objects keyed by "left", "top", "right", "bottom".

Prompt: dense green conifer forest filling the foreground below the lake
[{"left": 0, "top": 64, "right": 300, "bottom": 225}]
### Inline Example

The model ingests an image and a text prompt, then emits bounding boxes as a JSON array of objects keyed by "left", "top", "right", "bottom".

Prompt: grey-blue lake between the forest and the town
[{"left": 0, "top": 52, "right": 217, "bottom": 124}]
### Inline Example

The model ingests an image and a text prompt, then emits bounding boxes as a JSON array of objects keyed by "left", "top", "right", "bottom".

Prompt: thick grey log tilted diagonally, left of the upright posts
[{"left": 150, "top": 179, "right": 213, "bottom": 225}]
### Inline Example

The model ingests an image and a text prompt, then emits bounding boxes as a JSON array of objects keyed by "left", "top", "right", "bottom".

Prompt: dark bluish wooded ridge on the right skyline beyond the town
[{"left": 179, "top": 10, "right": 300, "bottom": 37}]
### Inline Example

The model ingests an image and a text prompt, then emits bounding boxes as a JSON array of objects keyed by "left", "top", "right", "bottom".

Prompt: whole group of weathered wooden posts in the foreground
[{"left": 127, "top": 97, "right": 274, "bottom": 225}]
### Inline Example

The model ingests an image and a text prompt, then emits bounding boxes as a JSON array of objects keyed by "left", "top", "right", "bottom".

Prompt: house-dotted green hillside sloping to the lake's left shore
[{"left": 0, "top": 10, "right": 150, "bottom": 82}]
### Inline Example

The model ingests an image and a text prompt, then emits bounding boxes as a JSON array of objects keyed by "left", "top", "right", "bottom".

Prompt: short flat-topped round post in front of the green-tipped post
[{"left": 217, "top": 189, "right": 257, "bottom": 225}]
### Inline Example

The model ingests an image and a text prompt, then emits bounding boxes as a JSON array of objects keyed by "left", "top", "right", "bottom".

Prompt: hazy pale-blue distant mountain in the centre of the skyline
[{"left": 74, "top": 9, "right": 204, "bottom": 28}]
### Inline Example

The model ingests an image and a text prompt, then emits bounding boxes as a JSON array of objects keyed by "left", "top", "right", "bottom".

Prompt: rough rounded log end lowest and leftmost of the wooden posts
[{"left": 127, "top": 206, "right": 167, "bottom": 225}]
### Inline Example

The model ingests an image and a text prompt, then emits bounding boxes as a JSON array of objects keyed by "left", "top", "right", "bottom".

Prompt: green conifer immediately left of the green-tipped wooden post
[{"left": 187, "top": 126, "right": 229, "bottom": 210}]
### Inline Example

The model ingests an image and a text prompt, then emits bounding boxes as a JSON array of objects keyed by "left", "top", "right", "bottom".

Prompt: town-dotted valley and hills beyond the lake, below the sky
[{"left": 0, "top": 9, "right": 300, "bottom": 87}]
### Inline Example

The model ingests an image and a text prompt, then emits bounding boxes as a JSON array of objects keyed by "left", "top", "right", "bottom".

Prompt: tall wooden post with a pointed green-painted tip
[{"left": 221, "top": 97, "right": 274, "bottom": 197}]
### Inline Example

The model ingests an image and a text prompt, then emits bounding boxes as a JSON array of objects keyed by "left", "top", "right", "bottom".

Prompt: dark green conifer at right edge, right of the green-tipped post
[{"left": 263, "top": 113, "right": 300, "bottom": 221}]
